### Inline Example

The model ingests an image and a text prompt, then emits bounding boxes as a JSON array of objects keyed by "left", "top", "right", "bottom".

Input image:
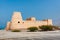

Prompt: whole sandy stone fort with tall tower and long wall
[{"left": 6, "top": 12, "right": 52, "bottom": 30}]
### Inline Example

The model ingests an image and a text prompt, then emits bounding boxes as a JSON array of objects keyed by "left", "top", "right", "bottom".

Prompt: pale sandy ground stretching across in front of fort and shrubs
[{"left": 0, "top": 30, "right": 60, "bottom": 40}]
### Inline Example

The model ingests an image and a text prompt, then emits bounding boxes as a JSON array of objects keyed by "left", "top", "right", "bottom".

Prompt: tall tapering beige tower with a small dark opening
[{"left": 10, "top": 12, "right": 22, "bottom": 29}]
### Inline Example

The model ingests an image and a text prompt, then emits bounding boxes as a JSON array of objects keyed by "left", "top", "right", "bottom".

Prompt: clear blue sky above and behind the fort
[{"left": 0, "top": 0, "right": 60, "bottom": 28}]
